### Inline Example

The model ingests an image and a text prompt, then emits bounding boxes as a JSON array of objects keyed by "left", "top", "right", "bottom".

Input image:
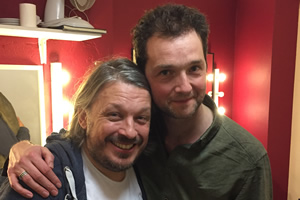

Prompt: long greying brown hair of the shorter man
[{"left": 65, "top": 58, "right": 150, "bottom": 147}]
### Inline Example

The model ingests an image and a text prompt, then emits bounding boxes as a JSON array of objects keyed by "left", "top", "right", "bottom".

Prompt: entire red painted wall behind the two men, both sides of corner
[{"left": 0, "top": 0, "right": 299, "bottom": 200}]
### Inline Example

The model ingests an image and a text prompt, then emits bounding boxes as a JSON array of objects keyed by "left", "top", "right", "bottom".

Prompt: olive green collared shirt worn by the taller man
[{"left": 137, "top": 96, "right": 272, "bottom": 200}]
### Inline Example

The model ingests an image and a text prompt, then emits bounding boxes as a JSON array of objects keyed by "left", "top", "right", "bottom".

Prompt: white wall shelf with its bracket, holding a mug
[{"left": 0, "top": 24, "right": 102, "bottom": 64}]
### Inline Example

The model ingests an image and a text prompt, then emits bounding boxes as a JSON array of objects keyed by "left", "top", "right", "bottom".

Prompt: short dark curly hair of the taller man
[{"left": 132, "top": 4, "right": 209, "bottom": 70}]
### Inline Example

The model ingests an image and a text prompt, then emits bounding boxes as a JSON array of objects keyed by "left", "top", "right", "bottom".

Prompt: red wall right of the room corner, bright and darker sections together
[{"left": 232, "top": 0, "right": 299, "bottom": 200}]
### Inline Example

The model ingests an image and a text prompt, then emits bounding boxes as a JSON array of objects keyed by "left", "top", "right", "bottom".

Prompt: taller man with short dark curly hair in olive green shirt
[{"left": 2, "top": 4, "right": 272, "bottom": 200}]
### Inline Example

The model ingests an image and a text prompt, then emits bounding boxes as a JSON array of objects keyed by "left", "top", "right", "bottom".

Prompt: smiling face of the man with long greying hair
[{"left": 79, "top": 82, "right": 151, "bottom": 172}]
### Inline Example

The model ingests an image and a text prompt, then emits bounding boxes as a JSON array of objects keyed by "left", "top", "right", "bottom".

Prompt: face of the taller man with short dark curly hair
[{"left": 145, "top": 31, "right": 206, "bottom": 119}]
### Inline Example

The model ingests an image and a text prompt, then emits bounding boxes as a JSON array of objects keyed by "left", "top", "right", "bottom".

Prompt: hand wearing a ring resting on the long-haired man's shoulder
[{"left": 7, "top": 142, "right": 61, "bottom": 198}]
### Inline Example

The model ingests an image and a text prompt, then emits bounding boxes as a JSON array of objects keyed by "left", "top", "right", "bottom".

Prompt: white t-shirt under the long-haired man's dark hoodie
[{"left": 81, "top": 150, "right": 142, "bottom": 200}]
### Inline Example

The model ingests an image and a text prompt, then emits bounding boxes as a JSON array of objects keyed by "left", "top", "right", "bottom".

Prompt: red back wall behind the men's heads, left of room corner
[{"left": 0, "top": 0, "right": 235, "bottom": 134}]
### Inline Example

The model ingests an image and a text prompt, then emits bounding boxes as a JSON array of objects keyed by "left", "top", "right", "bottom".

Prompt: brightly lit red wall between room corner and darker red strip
[{"left": 232, "top": 0, "right": 274, "bottom": 152}]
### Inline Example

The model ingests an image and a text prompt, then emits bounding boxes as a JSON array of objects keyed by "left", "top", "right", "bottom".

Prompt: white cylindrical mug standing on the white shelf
[{"left": 19, "top": 3, "right": 36, "bottom": 27}]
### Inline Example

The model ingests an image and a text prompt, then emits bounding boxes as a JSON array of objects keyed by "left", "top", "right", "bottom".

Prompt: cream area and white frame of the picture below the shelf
[{"left": 0, "top": 64, "right": 46, "bottom": 145}]
